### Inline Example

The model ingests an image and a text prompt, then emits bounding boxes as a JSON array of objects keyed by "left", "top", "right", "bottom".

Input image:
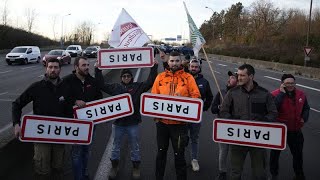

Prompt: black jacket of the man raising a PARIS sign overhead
[{"left": 95, "top": 64, "right": 158, "bottom": 126}]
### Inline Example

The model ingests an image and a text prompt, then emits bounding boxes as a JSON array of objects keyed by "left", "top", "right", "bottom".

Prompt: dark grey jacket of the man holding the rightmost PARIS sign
[{"left": 220, "top": 82, "right": 277, "bottom": 122}]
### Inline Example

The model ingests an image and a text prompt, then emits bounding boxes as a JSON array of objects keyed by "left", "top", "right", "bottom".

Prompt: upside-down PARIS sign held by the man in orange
[{"left": 140, "top": 93, "right": 203, "bottom": 123}]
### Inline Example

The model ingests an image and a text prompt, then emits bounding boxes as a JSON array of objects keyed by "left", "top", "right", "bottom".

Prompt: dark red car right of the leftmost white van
[{"left": 42, "top": 49, "right": 71, "bottom": 66}]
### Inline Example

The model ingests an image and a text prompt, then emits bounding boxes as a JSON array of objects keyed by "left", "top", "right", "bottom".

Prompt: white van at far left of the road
[{"left": 6, "top": 46, "right": 41, "bottom": 65}]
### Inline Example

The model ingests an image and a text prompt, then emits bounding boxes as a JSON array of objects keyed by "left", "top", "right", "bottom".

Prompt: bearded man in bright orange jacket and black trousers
[{"left": 151, "top": 51, "right": 201, "bottom": 180}]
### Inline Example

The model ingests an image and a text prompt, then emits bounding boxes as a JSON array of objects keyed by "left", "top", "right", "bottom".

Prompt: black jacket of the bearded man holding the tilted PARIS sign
[{"left": 63, "top": 71, "right": 103, "bottom": 102}]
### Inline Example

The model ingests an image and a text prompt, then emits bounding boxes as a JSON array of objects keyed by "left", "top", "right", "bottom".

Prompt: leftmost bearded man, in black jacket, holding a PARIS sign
[{"left": 12, "top": 59, "right": 72, "bottom": 180}]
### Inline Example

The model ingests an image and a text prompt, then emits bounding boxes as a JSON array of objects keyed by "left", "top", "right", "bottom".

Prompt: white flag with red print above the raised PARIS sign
[{"left": 108, "top": 8, "right": 150, "bottom": 48}]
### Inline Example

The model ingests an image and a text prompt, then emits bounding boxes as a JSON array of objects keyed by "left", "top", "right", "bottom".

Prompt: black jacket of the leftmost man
[{"left": 12, "top": 77, "right": 73, "bottom": 125}]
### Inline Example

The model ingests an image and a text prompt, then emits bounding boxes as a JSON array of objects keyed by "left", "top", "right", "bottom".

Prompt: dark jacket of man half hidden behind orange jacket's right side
[{"left": 195, "top": 74, "right": 213, "bottom": 111}]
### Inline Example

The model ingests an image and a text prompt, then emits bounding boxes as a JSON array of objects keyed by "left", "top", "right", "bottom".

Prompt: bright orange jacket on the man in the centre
[{"left": 151, "top": 69, "right": 201, "bottom": 124}]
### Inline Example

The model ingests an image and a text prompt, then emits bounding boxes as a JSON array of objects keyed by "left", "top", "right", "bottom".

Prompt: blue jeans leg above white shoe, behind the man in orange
[{"left": 188, "top": 123, "right": 201, "bottom": 160}]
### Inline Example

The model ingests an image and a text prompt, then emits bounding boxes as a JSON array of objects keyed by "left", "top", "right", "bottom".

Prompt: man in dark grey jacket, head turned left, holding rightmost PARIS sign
[{"left": 220, "top": 64, "right": 277, "bottom": 180}]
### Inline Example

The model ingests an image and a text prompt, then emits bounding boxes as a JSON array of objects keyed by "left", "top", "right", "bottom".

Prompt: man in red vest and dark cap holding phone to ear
[{"left": 270, "top": 74, "right": 310, "bottom": 180}]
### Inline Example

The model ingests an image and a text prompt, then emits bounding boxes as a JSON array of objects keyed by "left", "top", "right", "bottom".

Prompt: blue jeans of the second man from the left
[{"left": 72, "top": 145, "right": 90, "bottom": 180}]
